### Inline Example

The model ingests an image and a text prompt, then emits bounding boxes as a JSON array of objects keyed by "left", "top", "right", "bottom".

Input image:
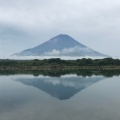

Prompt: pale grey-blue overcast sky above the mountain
[{"left": 0, "top": 0, "right": 120, "bottom": 58}]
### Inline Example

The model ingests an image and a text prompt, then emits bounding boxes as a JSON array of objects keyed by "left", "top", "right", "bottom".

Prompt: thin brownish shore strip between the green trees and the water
[{"left": 0, "top": 65, "right": 120, "bottom": 71}]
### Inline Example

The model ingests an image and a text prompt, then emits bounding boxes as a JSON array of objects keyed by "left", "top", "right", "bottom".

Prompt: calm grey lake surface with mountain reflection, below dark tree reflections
[{"left": 0, "top": 74, "right": 120, "bottom": 120}]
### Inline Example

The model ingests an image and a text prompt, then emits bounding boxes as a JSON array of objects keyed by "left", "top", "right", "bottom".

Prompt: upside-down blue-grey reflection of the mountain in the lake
[{"left": 16, "top": 74, "right": 105, "bottom": 100}]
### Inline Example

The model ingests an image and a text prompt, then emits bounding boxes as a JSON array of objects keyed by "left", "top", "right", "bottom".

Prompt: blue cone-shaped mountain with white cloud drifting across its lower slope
[{"left": 14, "top": 34, "right": 107, "bottom": 57}]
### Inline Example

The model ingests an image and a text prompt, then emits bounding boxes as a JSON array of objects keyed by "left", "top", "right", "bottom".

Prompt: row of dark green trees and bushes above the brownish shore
[{"left": 0, "top": 58, "right": 120, "bottom": 67}]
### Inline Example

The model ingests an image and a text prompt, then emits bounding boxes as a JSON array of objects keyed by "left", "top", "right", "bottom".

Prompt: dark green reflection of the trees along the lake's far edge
[{"left": 0, "top": 70, "right": 120, "bottom": 77}]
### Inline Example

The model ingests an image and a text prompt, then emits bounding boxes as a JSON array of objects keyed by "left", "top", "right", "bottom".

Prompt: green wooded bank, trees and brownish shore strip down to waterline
[{"left": 0, "top": 58, "right": 120, "bottom": 71}]
